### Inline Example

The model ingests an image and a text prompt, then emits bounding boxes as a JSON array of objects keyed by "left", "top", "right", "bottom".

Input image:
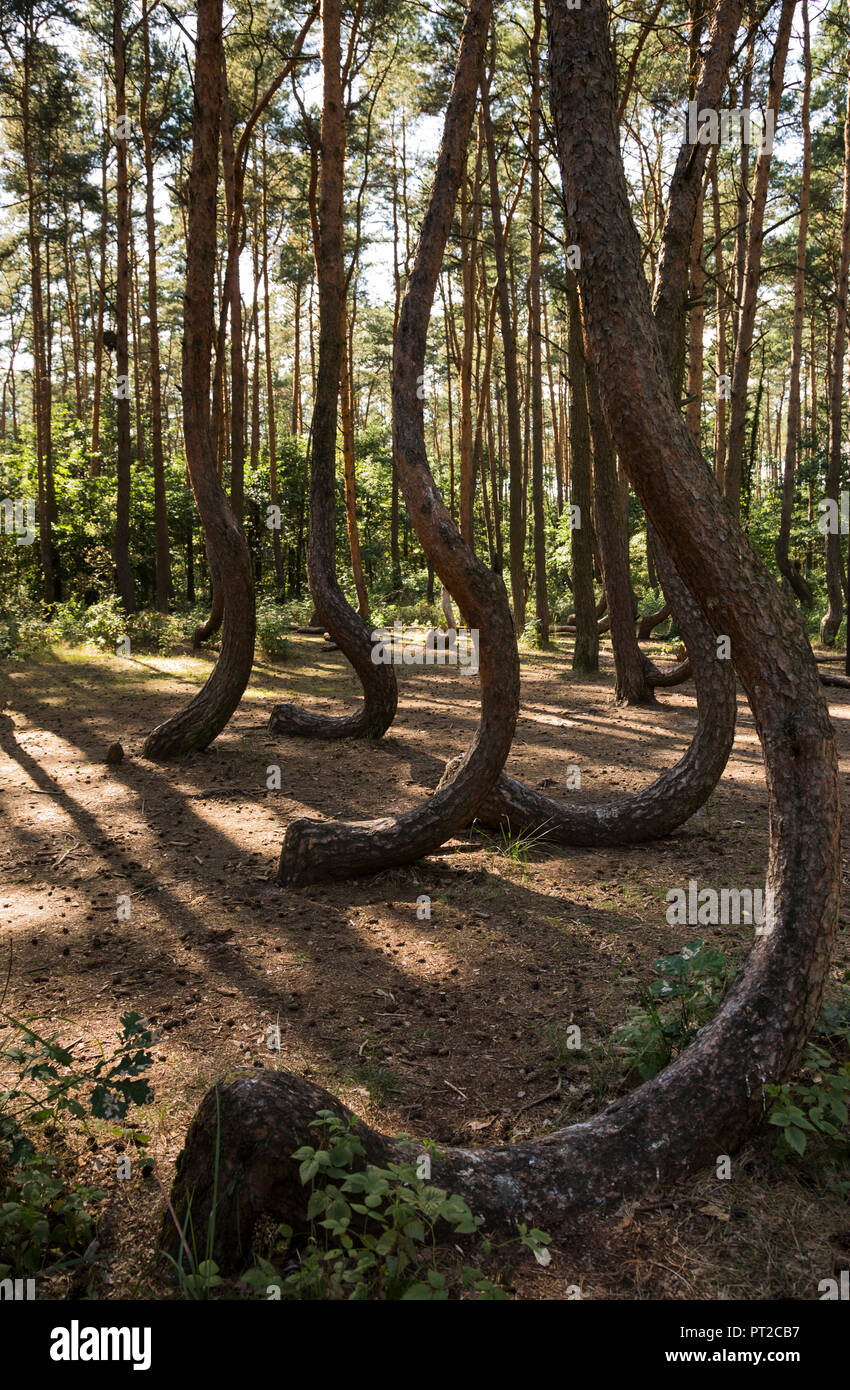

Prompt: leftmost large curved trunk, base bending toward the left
[{"left": 144, "top": 0, "right": 256, "bottom": 760}]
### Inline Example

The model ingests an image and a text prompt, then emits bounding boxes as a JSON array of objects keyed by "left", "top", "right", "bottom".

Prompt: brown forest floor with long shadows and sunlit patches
[{"left": 0, "top": 637, "right": 850, "bottom": 1300}]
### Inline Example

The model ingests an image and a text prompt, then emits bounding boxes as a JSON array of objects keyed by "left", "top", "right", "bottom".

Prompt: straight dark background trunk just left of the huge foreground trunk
[{"left": 567, "top": 271, "right": 599, "bottom": 671}]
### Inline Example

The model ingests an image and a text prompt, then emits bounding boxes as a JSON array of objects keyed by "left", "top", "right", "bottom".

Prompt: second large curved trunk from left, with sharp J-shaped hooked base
[{"left": 268, "top": 0, "right": 399, "bottom": 738}]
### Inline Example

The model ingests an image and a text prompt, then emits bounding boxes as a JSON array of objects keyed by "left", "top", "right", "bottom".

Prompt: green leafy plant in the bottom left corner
[{"left": 0, "top": 1013, "right": 153, "bottom": 1277}]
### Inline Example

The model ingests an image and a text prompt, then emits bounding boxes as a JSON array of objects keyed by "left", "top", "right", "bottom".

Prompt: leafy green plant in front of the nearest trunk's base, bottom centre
[{"left": 237, "top": 1111, "right": 550, "bottom": 1301}]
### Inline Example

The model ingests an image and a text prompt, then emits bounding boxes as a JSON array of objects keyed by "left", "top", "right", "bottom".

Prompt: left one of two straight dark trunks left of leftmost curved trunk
[{"left": 113, "top": 0, "right": 136, "bottom": 613}]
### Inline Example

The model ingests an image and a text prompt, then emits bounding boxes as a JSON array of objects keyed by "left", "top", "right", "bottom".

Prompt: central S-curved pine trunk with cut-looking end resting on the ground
[{"left": 278, "top": 0, "right": 519, "bottom": 883}]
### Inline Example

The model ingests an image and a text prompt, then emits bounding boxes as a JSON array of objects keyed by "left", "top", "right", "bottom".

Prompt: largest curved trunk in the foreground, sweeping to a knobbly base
[{"left": 164, "top": 0, "right": 840, "bottom": 1265}]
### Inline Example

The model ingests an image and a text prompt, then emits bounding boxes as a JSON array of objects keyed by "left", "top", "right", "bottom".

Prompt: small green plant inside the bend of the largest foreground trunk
[{"left": 613, "top": 941, "right": 733, "bottom": 1081}]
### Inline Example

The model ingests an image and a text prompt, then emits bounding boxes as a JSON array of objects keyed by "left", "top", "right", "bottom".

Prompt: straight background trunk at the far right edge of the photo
[{"left": 821, "top": 48, "right": 850, "bottom": 652}]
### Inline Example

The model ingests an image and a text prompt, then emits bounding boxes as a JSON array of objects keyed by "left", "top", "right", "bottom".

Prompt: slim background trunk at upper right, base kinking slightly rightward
[{"left": 774, "top": 0, "right": 814, "bottom": 605}]
